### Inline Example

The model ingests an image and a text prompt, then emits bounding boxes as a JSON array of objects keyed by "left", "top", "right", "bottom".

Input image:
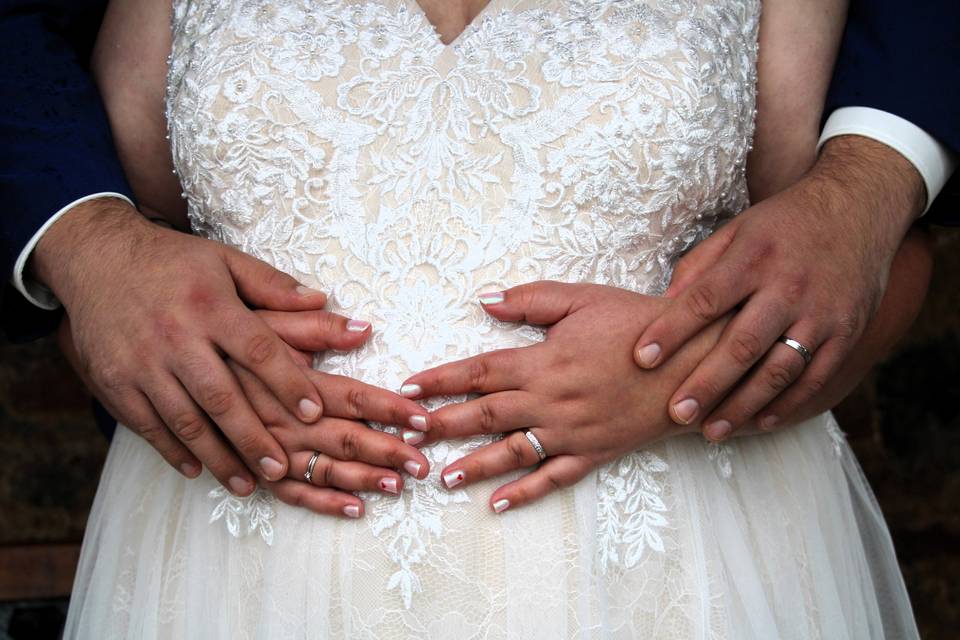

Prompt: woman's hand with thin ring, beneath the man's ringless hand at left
[{"left": 230, "top": 311, "right": 430, "bottom": 518}]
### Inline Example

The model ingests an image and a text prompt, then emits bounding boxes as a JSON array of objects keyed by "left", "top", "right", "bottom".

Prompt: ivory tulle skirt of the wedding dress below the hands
[{"left": 65, "top": 414, "right": 918, "bottom": 640}]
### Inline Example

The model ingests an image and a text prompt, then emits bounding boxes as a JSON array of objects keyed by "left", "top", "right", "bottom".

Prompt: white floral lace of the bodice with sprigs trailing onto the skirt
[{"left": 168, "top": 0, "right": 759, "bottom": 606}]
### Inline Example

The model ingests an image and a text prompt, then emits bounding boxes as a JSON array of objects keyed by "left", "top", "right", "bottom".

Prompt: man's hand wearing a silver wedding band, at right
[{"left": 634, "top": 136, "right": 925, "bottom": 440}]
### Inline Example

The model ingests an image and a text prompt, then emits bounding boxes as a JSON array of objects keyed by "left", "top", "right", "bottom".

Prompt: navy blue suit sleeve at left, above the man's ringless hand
[{"left": 0, "top": 0, "right": 132, "bottom": 337}]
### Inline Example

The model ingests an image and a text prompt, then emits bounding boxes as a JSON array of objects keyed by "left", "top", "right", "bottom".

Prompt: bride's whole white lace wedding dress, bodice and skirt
[{"left": 66, "top": 0, "right": 916, "bottom": 640}]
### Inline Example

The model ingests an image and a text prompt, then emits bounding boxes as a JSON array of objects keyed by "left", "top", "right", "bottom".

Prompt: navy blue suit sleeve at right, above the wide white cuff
[{"left": 827, "top": 0, "right": 960, "bottom": 225}]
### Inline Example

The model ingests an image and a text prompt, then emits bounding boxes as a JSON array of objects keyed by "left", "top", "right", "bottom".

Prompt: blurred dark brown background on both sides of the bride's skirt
[{"left": 0, "top": 230, "right": 960, "bottom": 640}]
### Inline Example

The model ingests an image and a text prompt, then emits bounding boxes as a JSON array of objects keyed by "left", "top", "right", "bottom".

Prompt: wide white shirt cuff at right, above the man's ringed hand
[{"left": 817, "top": 107, "right": 958, "bottom": 216}]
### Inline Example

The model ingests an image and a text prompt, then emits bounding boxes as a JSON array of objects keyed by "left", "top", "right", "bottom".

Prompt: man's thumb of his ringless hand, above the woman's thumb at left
[{"left": 224, "top": 247, "right": 327, "bottom": 311}]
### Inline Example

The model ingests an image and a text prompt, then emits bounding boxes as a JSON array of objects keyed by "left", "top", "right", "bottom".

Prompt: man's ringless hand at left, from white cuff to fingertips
[{"left": 37, "top": 199, "right": 338, "bottom": 495}]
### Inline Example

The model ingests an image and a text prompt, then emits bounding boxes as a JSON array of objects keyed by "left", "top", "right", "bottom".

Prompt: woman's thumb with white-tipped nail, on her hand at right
[{"left": 480, "top": 280, "right": 580, "bottom": 325}]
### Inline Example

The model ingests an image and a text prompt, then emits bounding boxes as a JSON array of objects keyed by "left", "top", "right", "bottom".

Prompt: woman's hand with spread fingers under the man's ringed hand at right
[{"left": 402, "top": 281, "right": 723, "bottom": 512}]
